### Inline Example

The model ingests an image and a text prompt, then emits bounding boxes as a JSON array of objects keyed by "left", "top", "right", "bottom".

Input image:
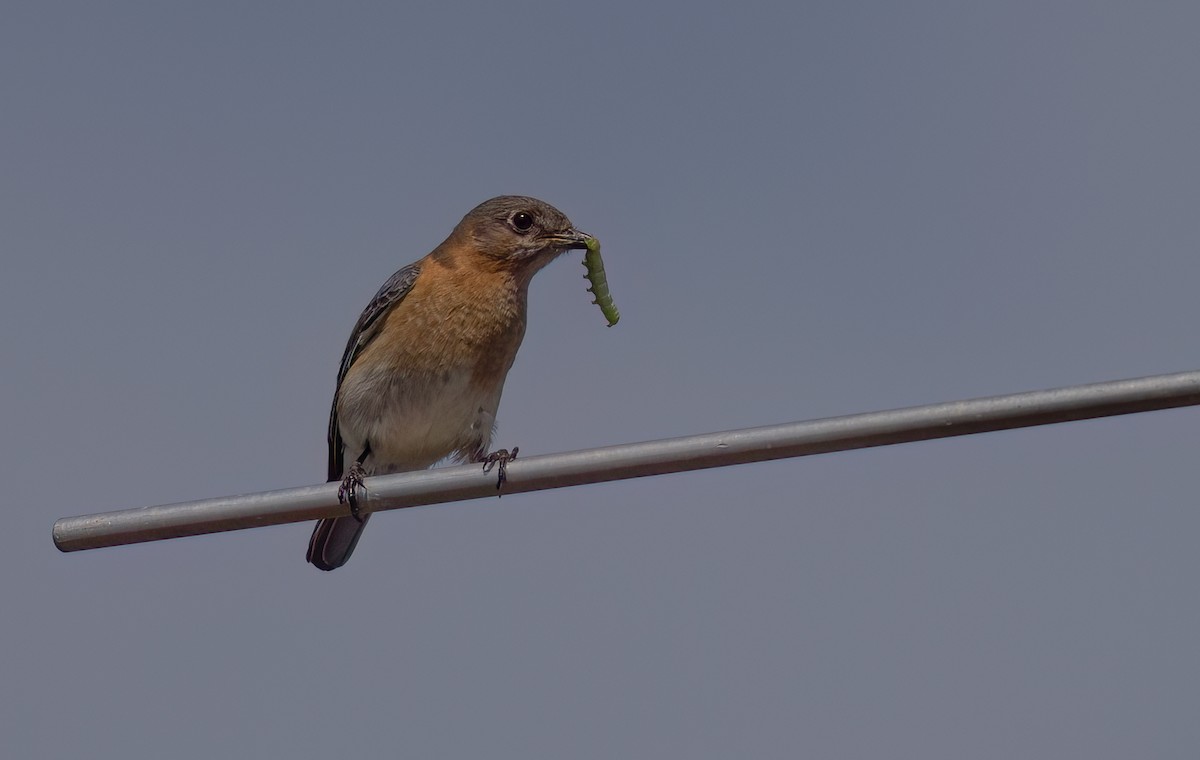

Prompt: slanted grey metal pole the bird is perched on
[{"left": 54, "top": 371, "right": 1200, "bottom": 551}]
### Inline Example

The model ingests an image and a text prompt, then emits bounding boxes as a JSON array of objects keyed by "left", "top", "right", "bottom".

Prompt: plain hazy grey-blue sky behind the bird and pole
[{"left": 0, "top": 0, "right": 1200, "bottom": 759}]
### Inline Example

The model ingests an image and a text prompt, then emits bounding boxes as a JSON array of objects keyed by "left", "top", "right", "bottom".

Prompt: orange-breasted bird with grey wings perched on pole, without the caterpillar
[{"left": 307, "top": 196, "right": 593, "bottom": 570}]
